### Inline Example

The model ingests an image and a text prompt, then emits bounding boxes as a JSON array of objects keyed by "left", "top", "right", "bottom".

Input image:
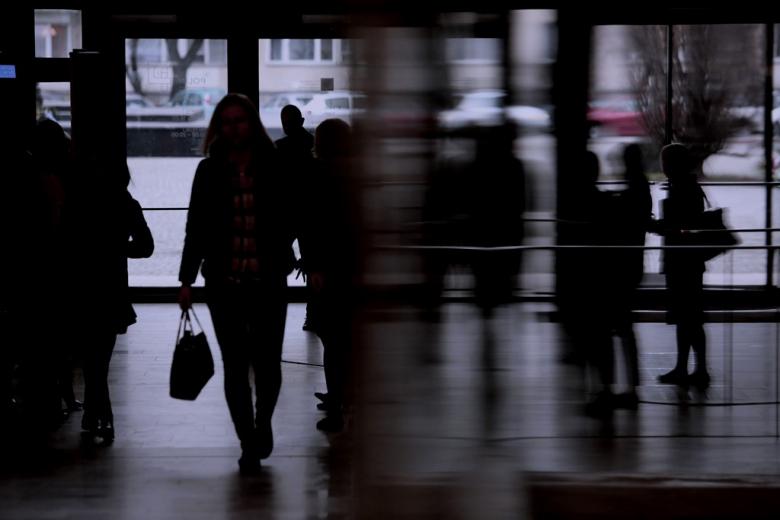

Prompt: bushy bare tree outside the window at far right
[{"left": 630, "top": 25, "right": 763, "bottom": 167}]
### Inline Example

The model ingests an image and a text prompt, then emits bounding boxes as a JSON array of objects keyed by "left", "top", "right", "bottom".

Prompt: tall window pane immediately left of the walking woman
[{"left": 125, "top": 39, "right": 227, "bottom": 286}]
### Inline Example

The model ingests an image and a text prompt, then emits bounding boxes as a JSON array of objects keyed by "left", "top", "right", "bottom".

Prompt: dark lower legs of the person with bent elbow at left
[{"left": 82, "top": 328, "right": 116, "bottom": 429}]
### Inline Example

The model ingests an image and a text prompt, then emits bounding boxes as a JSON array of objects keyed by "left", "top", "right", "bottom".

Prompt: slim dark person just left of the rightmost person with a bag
[{"left": 603, "top": 144, "right": 652, "bottom": 409}]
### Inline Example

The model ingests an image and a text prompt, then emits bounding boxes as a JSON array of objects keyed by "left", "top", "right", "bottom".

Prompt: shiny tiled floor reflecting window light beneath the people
[{"left": 0, "top": 304, "right": 780, "bottom": 519}]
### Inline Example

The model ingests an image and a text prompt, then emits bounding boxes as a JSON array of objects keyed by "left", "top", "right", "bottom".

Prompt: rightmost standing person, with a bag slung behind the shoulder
[{"left": 654, "top": 143, "right": 710, "bottom": 389}]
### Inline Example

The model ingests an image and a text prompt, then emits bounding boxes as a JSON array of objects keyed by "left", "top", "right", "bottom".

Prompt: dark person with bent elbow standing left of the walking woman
[{"left": 63, "top": 153, "right": 154, "bottom": 444}]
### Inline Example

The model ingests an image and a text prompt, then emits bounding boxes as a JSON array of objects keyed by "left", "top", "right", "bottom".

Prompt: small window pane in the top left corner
[{"left": 35, "top": 9, "right": 81, "bottom": 58}]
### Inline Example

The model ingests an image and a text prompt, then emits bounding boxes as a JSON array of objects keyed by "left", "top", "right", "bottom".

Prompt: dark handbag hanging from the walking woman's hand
[{"left": 170, "top": 309, "right": 214, "bottom": 401}]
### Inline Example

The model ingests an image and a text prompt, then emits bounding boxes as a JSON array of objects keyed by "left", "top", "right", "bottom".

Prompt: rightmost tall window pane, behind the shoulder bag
[{"left": 672, "top": 25, "right": 767, "bottom": 285}]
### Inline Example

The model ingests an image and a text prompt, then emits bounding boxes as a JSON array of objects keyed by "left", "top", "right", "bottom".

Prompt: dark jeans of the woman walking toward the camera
[{"left": 206, "top": 280, "right": 287, "bottom": 444}]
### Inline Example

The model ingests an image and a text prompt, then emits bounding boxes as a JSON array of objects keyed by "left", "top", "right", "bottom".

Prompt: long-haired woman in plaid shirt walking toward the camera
[{"left": 179, "top": 94, "right": 297, "bottom": 472}]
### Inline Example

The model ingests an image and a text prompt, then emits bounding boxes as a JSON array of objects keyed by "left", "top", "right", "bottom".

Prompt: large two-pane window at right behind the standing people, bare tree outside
[{"left": 588, "top": 25, "right": 770, "bottom": 285}]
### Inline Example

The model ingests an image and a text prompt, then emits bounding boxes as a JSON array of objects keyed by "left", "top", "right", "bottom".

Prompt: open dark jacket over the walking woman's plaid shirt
[{"left": 179, "top": 150, "right": 298, "bottom": 284}]
